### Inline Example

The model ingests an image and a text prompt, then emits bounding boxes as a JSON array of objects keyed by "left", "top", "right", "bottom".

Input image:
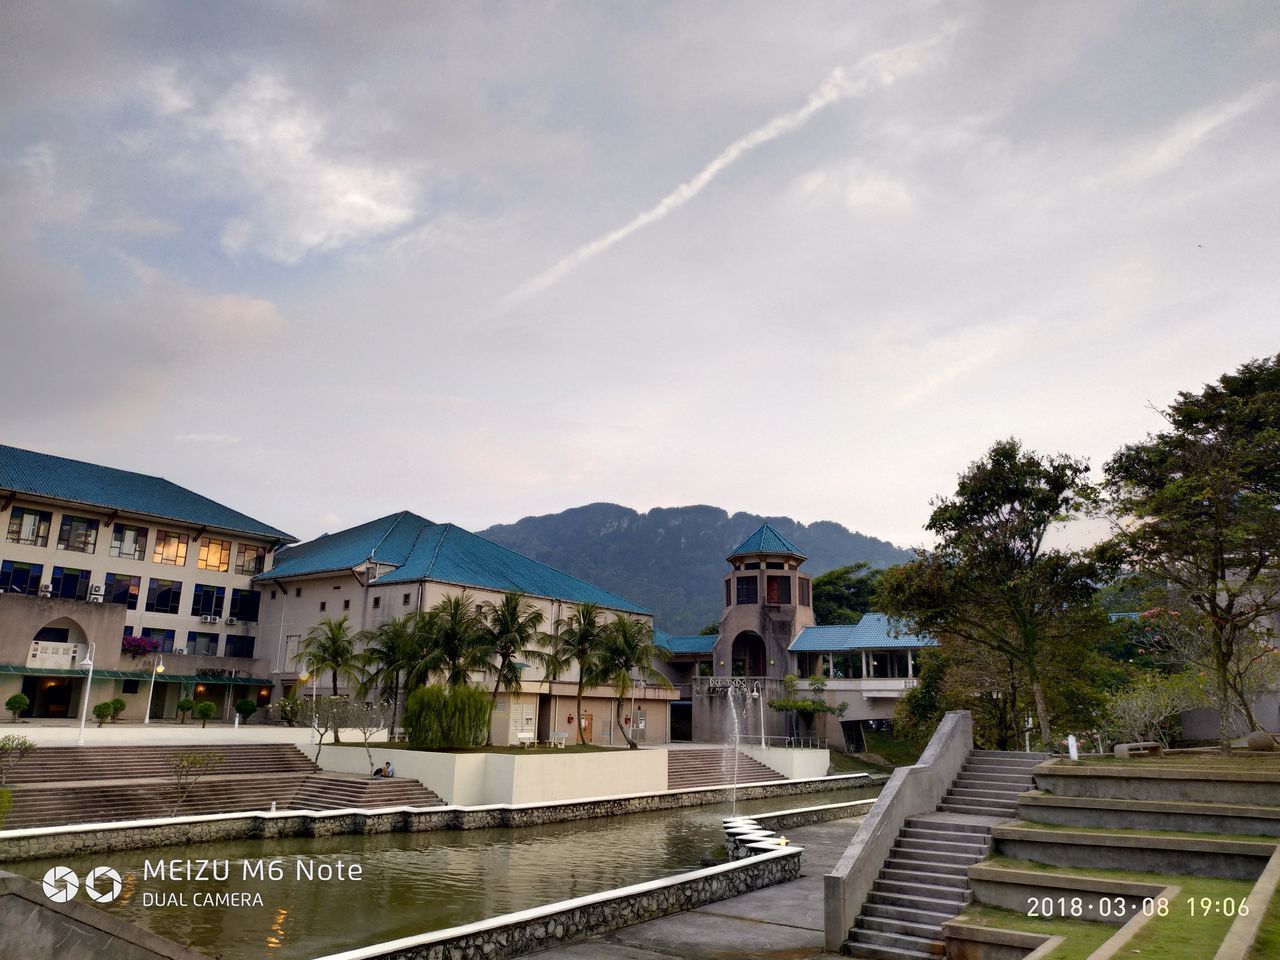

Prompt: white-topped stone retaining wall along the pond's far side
[{"left": 0, "top": 773, "right": 878, "bottom": 863}]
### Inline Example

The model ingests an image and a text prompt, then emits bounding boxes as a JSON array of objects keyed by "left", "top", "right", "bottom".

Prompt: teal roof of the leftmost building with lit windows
[{"left": 0, "top": 445, "right": 296, "bottom": 543}]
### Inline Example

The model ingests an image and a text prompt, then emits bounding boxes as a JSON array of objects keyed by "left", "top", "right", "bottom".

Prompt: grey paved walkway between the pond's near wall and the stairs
[{"left": 524, "top": 818, "right": 861, "bottom": 960}]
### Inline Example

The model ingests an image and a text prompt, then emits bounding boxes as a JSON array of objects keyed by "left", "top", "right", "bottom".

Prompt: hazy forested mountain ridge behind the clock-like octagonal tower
[{"left": 480, "top": 503, "right": 911, "bottom": 635}]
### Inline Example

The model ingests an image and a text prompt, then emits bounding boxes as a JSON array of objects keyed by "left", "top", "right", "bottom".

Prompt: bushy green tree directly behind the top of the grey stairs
[{"left": 879, "top": 439, "right": 1106, "bottom": 746}]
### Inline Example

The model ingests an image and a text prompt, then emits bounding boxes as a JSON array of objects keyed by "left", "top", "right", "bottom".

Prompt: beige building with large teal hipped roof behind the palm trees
[{"left": 255, "top": 511, "right": 675, "bottom": 745}]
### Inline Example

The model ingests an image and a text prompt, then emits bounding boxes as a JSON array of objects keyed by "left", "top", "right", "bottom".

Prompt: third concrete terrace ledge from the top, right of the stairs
[{"left": 992, "top": 826, "right": 1276, "bottom": 879}]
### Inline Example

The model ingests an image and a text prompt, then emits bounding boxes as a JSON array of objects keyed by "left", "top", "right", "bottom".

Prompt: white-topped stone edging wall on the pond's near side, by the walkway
[{"left": 307, "top": 847, "right": 800, "bottom": 960}]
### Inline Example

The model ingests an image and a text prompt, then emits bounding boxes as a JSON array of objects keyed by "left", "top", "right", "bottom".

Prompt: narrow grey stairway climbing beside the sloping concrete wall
[{"left": 845, "top": 750, "right": 1048, "bottom": 960}]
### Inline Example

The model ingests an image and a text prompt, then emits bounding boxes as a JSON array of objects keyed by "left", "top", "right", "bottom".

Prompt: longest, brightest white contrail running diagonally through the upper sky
[{"left": 499, "top": 26, "right": 955, "bottom": 312}]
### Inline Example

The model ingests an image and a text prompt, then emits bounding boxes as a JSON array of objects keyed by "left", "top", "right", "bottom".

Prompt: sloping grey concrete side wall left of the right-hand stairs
[{"left": 823, "top": 710, "right": 973, "bottom": 952}]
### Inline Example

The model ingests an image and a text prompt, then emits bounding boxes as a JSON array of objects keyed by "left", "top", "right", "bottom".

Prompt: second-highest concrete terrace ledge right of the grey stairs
[{"left": 1018, "top": 792, "right": 1280, "bottom": 837}]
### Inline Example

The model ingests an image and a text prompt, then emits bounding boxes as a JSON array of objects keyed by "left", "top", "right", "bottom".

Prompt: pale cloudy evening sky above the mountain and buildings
[{"left": 0, "top": 0, "right": 1280, "bottom": 545}]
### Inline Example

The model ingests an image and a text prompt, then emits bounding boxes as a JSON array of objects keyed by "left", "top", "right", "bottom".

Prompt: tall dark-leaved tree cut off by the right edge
[{"left": 1105, "top": 355, "right": 1280, "bottom": 753}]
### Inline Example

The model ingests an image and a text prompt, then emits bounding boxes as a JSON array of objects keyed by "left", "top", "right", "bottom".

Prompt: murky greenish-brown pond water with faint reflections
[{"left": 10, "top": 787, "right": 878, "bottom": 960}]
